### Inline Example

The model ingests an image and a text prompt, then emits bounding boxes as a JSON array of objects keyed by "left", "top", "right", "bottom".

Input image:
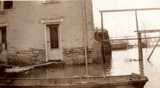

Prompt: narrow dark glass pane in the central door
[{"left": 47, "top": 24, "right": 59, "bottom": 49}]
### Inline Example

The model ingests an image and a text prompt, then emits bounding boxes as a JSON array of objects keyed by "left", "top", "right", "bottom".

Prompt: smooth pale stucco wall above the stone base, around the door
[{"left": 7, "top": 0, "right": 83, "bottom": 49}]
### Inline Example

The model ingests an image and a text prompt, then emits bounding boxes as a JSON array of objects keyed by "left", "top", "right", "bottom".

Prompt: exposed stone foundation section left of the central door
[{"left": 8, "top": 48, "right": 45, "bottom": 66}]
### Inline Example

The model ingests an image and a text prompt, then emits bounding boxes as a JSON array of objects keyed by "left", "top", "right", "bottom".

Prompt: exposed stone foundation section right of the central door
[{"left": 63, "top": 47, "right": 97, "bottom": 65}]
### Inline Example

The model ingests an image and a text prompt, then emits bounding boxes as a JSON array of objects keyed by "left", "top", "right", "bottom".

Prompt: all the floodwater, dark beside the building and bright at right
[{"left": 4, "top": 47, "right": 160, "bottom": 88}]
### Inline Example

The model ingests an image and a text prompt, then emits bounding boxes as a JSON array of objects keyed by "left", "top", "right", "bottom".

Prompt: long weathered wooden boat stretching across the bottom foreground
[{"left": 0, "top": 74, "right": 148, "bottom": 88}]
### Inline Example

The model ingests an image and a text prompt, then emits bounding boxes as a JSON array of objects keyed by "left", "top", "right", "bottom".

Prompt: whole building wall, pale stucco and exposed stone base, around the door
[{"left": 0, "top": 0, "right": 96, "bottom": 65}]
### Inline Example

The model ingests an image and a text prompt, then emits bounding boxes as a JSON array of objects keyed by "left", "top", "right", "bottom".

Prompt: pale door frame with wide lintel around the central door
[{"left": 41, "top": 18, "right": 63, "bottom": 62}]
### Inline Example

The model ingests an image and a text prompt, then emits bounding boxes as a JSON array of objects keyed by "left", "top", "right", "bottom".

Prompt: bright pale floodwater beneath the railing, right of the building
[{"left": 111, "top": 47, "right": 160, "bottom": 88}]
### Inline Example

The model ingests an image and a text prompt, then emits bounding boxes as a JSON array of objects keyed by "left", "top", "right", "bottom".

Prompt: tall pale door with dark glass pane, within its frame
[{"left": 46, "top": 24, "right": 63, "bottom": 61}]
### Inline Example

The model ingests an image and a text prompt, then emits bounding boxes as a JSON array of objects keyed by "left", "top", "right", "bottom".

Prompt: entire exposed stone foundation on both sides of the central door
[{"left": 8, "top": 47, "right": 100, "bottom": 66}]
